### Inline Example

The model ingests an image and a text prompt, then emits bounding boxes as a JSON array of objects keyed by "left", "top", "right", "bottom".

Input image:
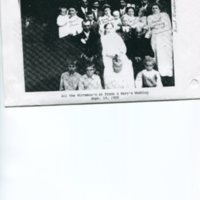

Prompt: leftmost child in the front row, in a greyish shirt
[{"left": 60, "top": 61, "right": 81, "bottom": 91}]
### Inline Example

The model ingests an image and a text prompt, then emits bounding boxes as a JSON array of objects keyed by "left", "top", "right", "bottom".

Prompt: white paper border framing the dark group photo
[{"left": 1, "top": 0, "right": 200, "bottom": 106}]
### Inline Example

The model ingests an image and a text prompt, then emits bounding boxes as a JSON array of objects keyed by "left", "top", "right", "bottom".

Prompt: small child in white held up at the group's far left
[{"left": 57, "top": 7, "right": 69, "bottom": 38}]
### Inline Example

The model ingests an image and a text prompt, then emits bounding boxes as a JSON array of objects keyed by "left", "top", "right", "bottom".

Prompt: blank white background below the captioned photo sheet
[{"left": 0, "top": 0, "right": 200, "bottom": 200}]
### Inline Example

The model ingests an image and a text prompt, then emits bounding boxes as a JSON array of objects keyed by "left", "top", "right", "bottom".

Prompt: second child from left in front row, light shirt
[{"left": 79, "top": 64, "right": 102, "bottom": 90}]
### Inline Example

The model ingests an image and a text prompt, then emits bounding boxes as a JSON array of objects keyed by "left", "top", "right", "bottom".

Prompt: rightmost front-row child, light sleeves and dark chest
[{"left": 135, "top": 56, "right": 163, "bottom": 88}]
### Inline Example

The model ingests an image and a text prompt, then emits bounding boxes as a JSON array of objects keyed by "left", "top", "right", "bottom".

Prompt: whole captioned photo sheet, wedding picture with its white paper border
[{"left": 1, "top": 0, "right": 200, "bottom": 106}]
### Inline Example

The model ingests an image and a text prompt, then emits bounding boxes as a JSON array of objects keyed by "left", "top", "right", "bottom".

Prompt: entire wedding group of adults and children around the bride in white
[{"left": 57, "top": 0, "right": 174, "bottom": 90}]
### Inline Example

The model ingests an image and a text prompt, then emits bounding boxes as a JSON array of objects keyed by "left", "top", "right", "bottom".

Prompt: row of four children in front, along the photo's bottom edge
[{"left": 60, "top": 55, "right": 162, "bottom": 91}]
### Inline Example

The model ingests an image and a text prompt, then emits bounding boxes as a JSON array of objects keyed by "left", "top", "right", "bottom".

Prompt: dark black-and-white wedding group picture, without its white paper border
[{"left": 20, "top": 0, "right": 175, "bottom": 92}]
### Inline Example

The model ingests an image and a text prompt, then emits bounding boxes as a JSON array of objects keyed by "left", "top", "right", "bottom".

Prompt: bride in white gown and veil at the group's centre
[{"left": 101, "top": 23, "right": 134, "bottom": 88}]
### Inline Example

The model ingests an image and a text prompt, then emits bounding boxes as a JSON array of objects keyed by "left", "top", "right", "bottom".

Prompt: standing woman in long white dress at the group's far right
[{"left": 147, "top": 3, "right": 173, "bottom": 77}]
